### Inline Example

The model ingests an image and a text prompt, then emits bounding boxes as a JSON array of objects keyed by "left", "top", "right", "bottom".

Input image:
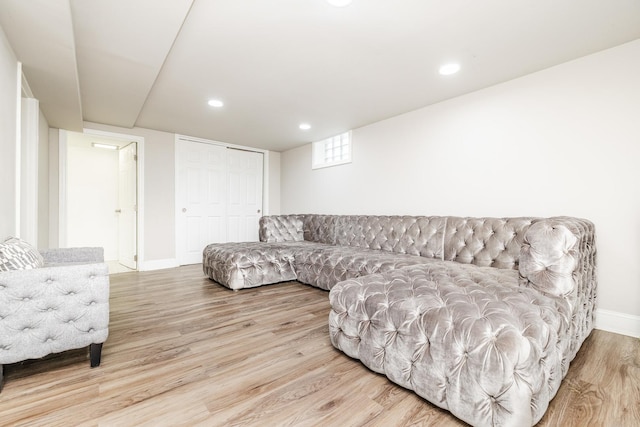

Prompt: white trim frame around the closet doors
[{"left": 173, "top": 134, "right": 270, "bottom": 263}]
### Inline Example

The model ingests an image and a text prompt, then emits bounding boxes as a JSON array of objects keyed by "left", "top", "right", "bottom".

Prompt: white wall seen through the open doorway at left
[{"left": 66, "top": 138, "right": 118, "bottom": 260}]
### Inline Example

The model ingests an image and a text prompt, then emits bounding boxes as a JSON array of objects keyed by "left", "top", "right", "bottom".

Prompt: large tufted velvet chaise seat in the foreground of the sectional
[{"left": 329, "top": 263, "right": 571, "bottom": 426}]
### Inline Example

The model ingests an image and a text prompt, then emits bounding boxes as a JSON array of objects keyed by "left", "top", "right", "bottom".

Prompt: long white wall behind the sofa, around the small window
[{"left": 281, "top": 40, "right": 640, "bottom": 335}]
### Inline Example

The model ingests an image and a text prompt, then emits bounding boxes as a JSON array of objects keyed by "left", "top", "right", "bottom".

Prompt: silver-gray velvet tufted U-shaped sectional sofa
[{"left": 203, "top": 215, "right": 596, "bottom": 426}]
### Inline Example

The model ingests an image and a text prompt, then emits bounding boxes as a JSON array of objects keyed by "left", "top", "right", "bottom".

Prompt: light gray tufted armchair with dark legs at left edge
[{"left": 0, "top": 248, "right": 109, "bottom": 390}]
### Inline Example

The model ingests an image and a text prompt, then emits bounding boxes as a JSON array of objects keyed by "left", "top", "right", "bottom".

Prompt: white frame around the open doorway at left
[{"left": 57, "top": 128, "right": 144, "bottom": 271}]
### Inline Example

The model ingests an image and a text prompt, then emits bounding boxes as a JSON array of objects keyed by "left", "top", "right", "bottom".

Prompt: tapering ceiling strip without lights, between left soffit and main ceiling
[{"left": 71, "top": 0, "right": 193, "bottom": 127}]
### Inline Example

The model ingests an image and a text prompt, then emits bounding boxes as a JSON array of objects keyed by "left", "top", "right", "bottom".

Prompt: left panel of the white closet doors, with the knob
[{"left": 176, "top": 140, "right": 228, "bottom": 265}]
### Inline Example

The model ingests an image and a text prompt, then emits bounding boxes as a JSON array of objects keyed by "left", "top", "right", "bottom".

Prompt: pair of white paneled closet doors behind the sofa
[{"left": 176, "top": 139, "right": 263, "bottom": 265}]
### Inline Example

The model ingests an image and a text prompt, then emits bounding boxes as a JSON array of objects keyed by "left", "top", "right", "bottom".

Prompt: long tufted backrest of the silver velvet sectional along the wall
[{"left": 260, "top": 215, "right": 590, "bottom": 280}]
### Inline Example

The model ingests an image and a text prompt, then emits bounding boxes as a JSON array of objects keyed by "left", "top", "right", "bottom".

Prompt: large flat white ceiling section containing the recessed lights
[{"left": 138, "top": 0, "right": 640, "bottom": 150}]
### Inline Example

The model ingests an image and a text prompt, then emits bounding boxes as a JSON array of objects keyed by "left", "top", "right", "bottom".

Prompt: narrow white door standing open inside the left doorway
[{"left": 116, "top": 142, "right": 138, "bottom": 270}]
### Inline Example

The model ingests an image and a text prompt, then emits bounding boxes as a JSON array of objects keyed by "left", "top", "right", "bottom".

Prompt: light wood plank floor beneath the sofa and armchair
[{"left": 0, "top": 265, "right": 640, "bottom": 426}]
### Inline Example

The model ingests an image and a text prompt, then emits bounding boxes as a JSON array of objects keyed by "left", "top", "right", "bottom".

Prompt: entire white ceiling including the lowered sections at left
[{"left": 0, "top": 0, "right": 640, "bottom": 151}]
